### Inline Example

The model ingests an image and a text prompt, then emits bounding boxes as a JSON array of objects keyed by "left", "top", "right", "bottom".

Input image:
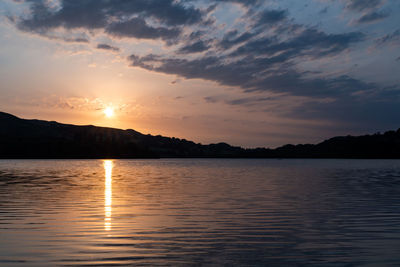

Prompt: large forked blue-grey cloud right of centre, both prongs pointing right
[{"left": 125, "top": 18, "right": 366, "bottom": 97}]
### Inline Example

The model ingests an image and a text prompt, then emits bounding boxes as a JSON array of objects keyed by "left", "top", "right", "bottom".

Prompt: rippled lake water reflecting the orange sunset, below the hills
[{"left": 0, "top": 159, "right": 400, "bottom": 266}]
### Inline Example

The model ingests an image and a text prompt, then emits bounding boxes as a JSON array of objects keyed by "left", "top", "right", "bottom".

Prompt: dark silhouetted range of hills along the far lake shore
[{"left": 0, "top": 112, "right": 400, "bottom": 158}]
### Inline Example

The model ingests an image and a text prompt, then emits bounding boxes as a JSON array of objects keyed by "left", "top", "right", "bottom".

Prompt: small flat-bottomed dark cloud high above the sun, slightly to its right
[{"left": 106, "top": 18, "right": 180, "bottom": 40}]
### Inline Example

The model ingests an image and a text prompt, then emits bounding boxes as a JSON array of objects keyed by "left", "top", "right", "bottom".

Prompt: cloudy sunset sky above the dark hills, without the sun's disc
[{"left": 0, "top": 0, "right": 400, "bottom": 147}]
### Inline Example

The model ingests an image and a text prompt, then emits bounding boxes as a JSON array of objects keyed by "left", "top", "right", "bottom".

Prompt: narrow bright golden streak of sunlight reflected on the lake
[{"left": 104, "top": 160, "right": 113, "bottom": 231}]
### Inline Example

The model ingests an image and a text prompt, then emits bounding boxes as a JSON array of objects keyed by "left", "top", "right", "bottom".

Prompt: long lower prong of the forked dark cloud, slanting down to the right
[{"left": 129, "top": 51, "right": 376, "bottom": 98}]
